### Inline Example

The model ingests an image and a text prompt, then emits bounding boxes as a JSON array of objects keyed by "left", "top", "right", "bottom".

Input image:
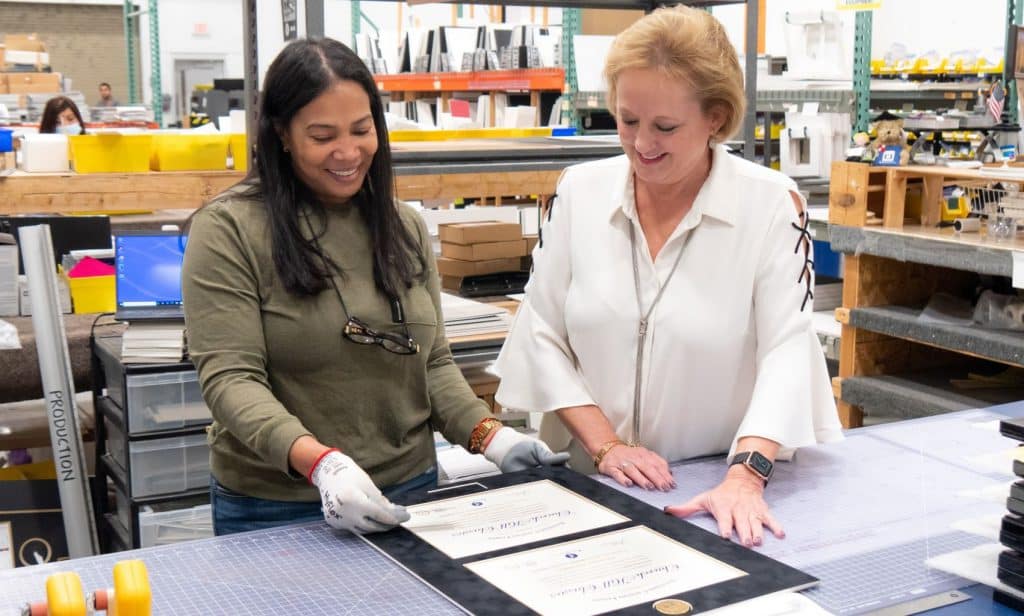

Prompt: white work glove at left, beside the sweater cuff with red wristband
[{"left": 309, "top": 449, "right": 410, "bottom": 534}]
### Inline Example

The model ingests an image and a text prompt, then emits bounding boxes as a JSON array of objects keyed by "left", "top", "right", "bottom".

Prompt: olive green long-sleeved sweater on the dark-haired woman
[{"left": 181, "top": 187, "right": 487, "bottom": 500}]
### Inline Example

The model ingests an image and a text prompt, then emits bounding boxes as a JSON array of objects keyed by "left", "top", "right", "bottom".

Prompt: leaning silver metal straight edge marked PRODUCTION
[{"left": 18, "top": 225, "right": 99, "bottom": 559}]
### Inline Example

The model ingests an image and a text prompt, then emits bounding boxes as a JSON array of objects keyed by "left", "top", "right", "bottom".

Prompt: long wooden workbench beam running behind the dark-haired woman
[{"left": 0, "top": 138, "right": 621, "bottom": 214}]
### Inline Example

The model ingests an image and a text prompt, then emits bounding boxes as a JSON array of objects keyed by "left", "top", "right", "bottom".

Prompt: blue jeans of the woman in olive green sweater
[{"left": 210, "top": 468, "right": 437, "bottom": 535}]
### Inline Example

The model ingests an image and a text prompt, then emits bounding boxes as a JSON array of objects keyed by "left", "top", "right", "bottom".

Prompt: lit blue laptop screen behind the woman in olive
[{"left": 114, "top": 231, "right": 185, "bottom": 311}]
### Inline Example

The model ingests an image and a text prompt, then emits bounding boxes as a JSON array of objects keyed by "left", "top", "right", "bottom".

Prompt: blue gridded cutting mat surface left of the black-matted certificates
[{"left": 0, "top": 523, "right": 463, "bottom": 616}]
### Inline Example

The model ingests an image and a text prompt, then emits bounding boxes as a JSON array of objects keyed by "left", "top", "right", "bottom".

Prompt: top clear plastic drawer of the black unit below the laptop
[{"left": 120, "top": 370, "right": 212, "bottom": 434}]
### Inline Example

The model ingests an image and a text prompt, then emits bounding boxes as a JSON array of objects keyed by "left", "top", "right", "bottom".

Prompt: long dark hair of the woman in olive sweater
[{"left": 246, "top": 39, "right": 426, "bottom": 297}]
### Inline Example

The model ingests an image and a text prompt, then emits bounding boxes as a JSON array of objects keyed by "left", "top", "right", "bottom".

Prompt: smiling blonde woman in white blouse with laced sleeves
[{"left": 497, "top": 6, "right": 842, "bottom": 545}]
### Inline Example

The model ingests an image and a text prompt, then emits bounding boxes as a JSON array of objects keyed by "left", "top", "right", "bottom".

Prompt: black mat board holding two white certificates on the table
[{"left": 362, "top": 467, "right": 817, "bottom": 616}]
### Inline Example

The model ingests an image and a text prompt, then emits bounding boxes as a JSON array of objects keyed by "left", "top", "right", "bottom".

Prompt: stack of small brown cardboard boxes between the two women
[{"left": 437, "top": 221, "right": 528, "bottom": 291}]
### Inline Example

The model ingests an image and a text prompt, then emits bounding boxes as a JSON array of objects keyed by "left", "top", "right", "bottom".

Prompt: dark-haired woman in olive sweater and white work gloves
[{"left": 182, "top": 39, "right": 567, "bottom": 534}]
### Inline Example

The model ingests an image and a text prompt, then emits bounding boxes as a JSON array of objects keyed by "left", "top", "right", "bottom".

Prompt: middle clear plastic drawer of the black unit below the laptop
[{"left": 128, "top": 434, "right": 210, "bottom": 498}]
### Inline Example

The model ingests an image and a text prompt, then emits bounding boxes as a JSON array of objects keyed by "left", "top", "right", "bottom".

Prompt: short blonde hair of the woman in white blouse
[{"left": 604, "top": 6, "right": 745, "bottom": 141}]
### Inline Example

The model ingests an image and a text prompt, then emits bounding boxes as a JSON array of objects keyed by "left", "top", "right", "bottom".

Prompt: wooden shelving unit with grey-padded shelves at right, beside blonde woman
[{"left": 829, "top": 162, "right": 1024, "bottom": 427}]
